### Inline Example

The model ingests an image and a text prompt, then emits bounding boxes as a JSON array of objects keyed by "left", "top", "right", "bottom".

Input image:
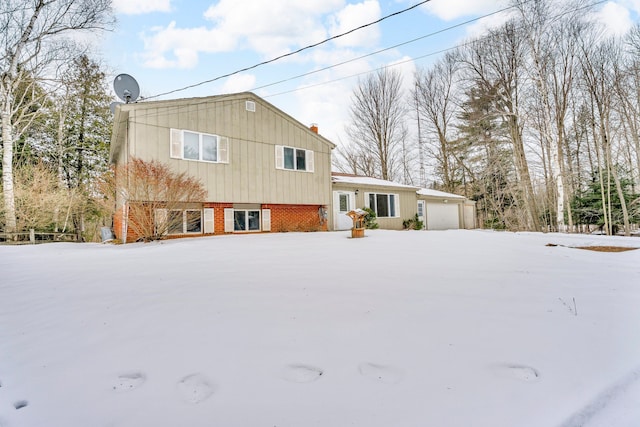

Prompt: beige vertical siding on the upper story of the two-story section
[{"left": 119, "top": 93, "right": 332, "bottom": 205}]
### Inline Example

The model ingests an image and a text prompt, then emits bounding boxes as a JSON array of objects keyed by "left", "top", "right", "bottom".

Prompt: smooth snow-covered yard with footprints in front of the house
[{"left": 0, "top": 230, "right": 640, "bottom": 427}]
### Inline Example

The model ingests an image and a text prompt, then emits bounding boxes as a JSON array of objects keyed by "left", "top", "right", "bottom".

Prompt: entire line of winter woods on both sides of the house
[{"left": 0, "top": 0, "right": 640, "bottom": 241}]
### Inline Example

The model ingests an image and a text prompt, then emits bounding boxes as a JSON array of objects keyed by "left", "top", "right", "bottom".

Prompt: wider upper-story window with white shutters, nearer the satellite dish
[{"left": 171, "top": 129, "right": 229, "bottom": 163}]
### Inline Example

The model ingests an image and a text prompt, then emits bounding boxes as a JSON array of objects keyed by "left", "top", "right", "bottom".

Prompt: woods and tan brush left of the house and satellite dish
[{"left": 0, "top": 0, "right": 114, "bottom": 238}]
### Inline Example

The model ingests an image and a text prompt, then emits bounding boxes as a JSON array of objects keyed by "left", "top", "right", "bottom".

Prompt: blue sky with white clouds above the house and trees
[{"left": 102, "top": 0, "right": 640, "bottom": 144}]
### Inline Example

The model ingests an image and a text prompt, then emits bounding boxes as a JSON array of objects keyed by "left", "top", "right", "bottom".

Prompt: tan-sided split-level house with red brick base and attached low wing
[{"left": 110, "top": 92, "right": 470, "bottom": 241}]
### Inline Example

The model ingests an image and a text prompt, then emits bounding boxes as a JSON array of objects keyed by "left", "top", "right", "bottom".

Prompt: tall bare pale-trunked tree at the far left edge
[{"left": 0, "top": 0, "right": 113, "bottom": 232}]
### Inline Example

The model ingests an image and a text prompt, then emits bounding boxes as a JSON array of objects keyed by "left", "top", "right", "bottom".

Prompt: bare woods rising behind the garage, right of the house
[{"left": 335, "top": 0, "right": 640, "bottom": 234}]
